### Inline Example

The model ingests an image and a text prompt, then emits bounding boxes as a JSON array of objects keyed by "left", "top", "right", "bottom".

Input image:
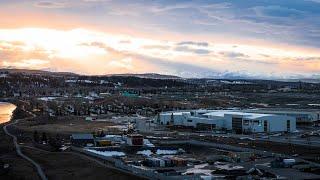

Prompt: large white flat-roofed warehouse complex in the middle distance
[{"left": 158, "top": 110, "right": 296, "bottom": 133}]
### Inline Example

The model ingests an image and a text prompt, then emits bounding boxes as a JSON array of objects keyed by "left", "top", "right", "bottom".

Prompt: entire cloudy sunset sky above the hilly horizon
[{"left": 0, "top": 0, "right": 320, "bottom": 79}]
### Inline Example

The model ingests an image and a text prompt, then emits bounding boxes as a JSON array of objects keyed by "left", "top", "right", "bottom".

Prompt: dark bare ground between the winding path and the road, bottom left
[{"left": 23, "top": 148, "right": 136, "bottom": 180}]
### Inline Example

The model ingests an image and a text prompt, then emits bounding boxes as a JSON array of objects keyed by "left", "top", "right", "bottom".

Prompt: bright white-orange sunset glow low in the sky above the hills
[{"left": 0, "top": 28, "right": 320, "bottom": 75}]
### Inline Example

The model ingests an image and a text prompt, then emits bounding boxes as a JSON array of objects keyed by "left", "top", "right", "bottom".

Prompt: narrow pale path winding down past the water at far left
[{"left": 3, "top": 113, "right": 48, "bottom": 180}]
